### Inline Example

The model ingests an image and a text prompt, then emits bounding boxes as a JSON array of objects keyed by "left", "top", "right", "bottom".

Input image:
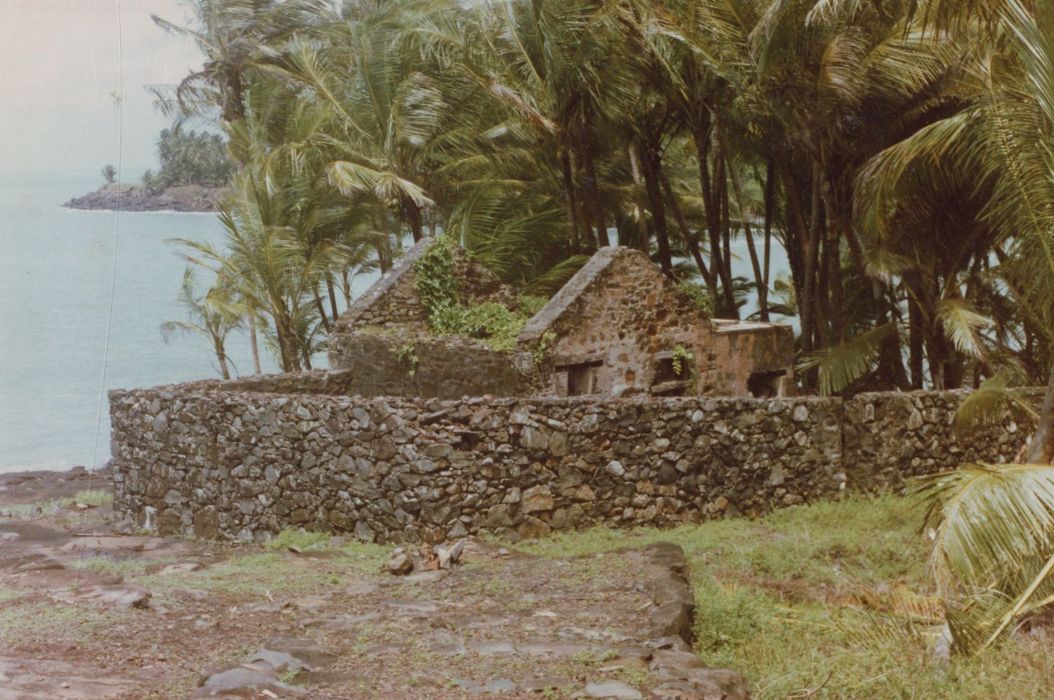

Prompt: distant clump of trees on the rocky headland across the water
[{"left": 142, "top": 124, "right": 233, "bottom": 194}]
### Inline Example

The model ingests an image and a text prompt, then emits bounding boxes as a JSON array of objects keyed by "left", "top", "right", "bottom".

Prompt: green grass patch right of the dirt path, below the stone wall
[{"left": 519, "top": 497, "right": 1054, "bottom": 700}]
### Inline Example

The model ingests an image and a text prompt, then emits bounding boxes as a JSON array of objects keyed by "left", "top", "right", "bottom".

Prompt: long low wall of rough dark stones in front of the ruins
[{"left": 111, "top": 383, "right": 1037, "bottom": 542}]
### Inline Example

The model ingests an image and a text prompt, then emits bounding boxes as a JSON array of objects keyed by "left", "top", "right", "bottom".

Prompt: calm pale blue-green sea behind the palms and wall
[{"left": 0, "top": 171, "right": 786, "bottom": 472}]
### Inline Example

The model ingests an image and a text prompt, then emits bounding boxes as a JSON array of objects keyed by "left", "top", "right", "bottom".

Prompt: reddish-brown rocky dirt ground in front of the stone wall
[{"left": 0, "top": 470, "right": 738, "bottom": 700}]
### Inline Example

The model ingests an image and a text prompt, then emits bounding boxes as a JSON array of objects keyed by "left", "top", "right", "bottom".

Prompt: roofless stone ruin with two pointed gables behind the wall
[{"left": 330, "top": 238, "right": 794, "bottom": 398}]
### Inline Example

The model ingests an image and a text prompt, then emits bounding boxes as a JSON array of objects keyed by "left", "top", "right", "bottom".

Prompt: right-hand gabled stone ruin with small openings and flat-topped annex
[{"left": 520, "top": 248, "right": 794, "bottom": 396}]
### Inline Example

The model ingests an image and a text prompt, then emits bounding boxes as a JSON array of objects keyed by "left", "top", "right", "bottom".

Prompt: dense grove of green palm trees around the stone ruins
[{"left": 153, "top": 0, "right": 1054, "bottom": 657}]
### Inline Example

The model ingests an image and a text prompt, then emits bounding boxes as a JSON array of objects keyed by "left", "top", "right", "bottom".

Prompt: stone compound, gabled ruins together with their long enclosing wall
[{"left": 110, "top": 240, "right": 1023, "bottom": 542}]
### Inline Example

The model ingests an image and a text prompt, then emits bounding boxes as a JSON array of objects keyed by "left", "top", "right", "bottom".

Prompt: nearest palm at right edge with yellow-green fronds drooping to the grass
[{"left": 911, "top": 0, "right": 1054, "bottom": 650}]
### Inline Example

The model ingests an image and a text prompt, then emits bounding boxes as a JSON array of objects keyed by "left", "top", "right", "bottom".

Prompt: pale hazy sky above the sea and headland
[{"left": 0, "top": 0, "right": 202, "bottom": 175}]
